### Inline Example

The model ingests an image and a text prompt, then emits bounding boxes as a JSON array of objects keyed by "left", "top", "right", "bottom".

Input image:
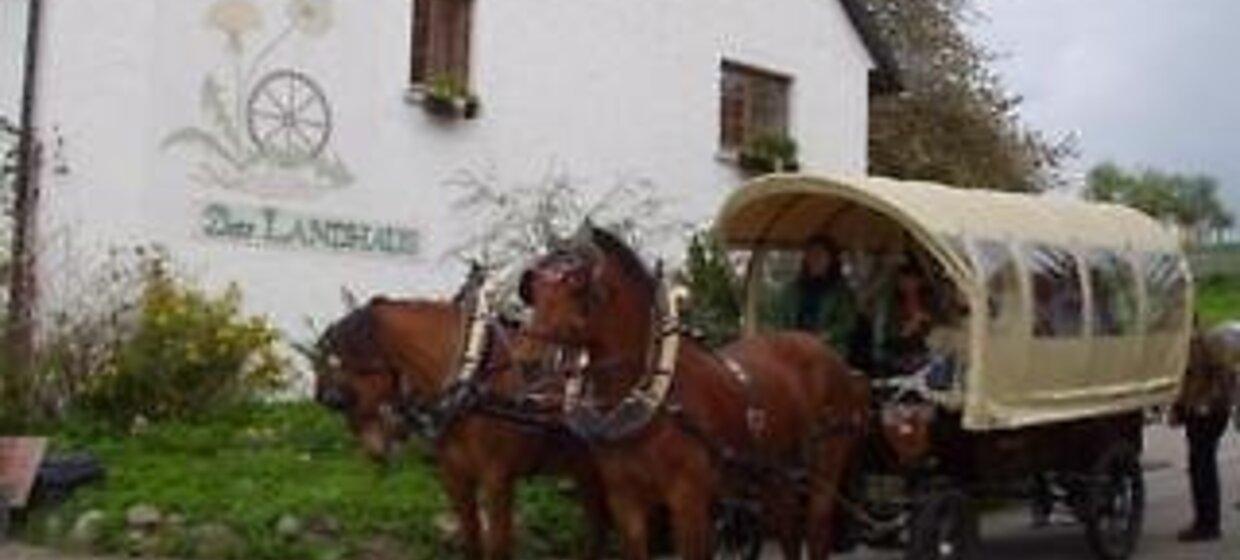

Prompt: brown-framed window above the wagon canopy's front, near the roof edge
[{"left": 719, "top": 62, "right": 791, "bottom": 151}]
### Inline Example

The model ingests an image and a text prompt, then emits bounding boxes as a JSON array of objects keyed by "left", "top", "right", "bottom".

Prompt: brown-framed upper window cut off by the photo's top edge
[{"left": 409, "top": 0, "right": 474, "bottom": 87}]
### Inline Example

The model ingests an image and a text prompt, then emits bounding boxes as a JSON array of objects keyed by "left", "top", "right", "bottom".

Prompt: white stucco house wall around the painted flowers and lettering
[{"left": 33, "top": 0, "right": 870, "bottom": 336}]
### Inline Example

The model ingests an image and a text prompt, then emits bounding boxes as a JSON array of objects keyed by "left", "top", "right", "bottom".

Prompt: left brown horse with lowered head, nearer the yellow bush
[{"left": 315, "top": 288, "right": 606, "bottom": 559}]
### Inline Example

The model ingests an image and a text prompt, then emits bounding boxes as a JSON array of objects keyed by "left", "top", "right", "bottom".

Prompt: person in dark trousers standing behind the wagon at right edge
[{"left": 1171, "top": 327, "right": 1240, "bottom": 543}]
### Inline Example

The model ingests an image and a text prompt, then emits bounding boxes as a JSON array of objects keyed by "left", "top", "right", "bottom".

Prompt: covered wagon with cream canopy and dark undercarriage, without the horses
[{"left": 715, "top": 175, "right": 1192, "bottom": 559}]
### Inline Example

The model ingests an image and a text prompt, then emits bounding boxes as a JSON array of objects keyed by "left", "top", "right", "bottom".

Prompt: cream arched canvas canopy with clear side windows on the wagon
[{"left": 715, "top": 175, "right": 1192, "bottom": 430}]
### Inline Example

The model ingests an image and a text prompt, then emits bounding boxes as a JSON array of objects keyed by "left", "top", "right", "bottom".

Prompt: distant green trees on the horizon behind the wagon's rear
[{"left": 1085, "top": 162, "right": 1234, "bottom": 242}]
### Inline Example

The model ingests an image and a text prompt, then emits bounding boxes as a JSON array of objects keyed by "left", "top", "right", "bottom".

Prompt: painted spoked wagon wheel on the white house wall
[{"left": 246, "top": 69, "right": 331, "bottom": 166}]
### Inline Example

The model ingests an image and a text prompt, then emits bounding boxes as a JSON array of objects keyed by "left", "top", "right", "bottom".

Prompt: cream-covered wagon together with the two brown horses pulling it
[{"left": 316, "top": 175, "right": 1192, "bottom": 560}]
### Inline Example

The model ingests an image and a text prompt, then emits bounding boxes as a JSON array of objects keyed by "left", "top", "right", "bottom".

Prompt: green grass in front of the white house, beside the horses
[{"left": 24, "top": 403, "right": 579, "bottom": 560}]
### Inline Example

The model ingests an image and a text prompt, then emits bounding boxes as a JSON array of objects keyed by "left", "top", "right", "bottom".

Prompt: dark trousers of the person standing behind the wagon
[{"left": 1184, "top": 410, "right": 1229, "bottom": 530}]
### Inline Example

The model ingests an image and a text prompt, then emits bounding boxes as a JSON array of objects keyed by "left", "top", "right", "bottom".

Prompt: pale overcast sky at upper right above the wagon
[{"left": 976, "top": 0, "right": 1240, "bottom": 213}]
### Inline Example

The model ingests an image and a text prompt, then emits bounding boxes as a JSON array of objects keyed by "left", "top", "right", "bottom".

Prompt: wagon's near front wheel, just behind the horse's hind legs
[{"left": 904, "top": 489, "right": 978, "bottom": 560}]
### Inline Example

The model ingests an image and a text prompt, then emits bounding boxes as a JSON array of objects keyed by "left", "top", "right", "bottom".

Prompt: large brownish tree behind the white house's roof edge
[{"left": 867, "top": 0, "right": 1075, "bottom": 191}]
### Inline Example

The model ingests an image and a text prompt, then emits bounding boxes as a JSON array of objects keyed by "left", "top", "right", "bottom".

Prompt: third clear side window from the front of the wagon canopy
[{"left": 1087, "top": 250, "right": 1137, "bottom": 336}]
